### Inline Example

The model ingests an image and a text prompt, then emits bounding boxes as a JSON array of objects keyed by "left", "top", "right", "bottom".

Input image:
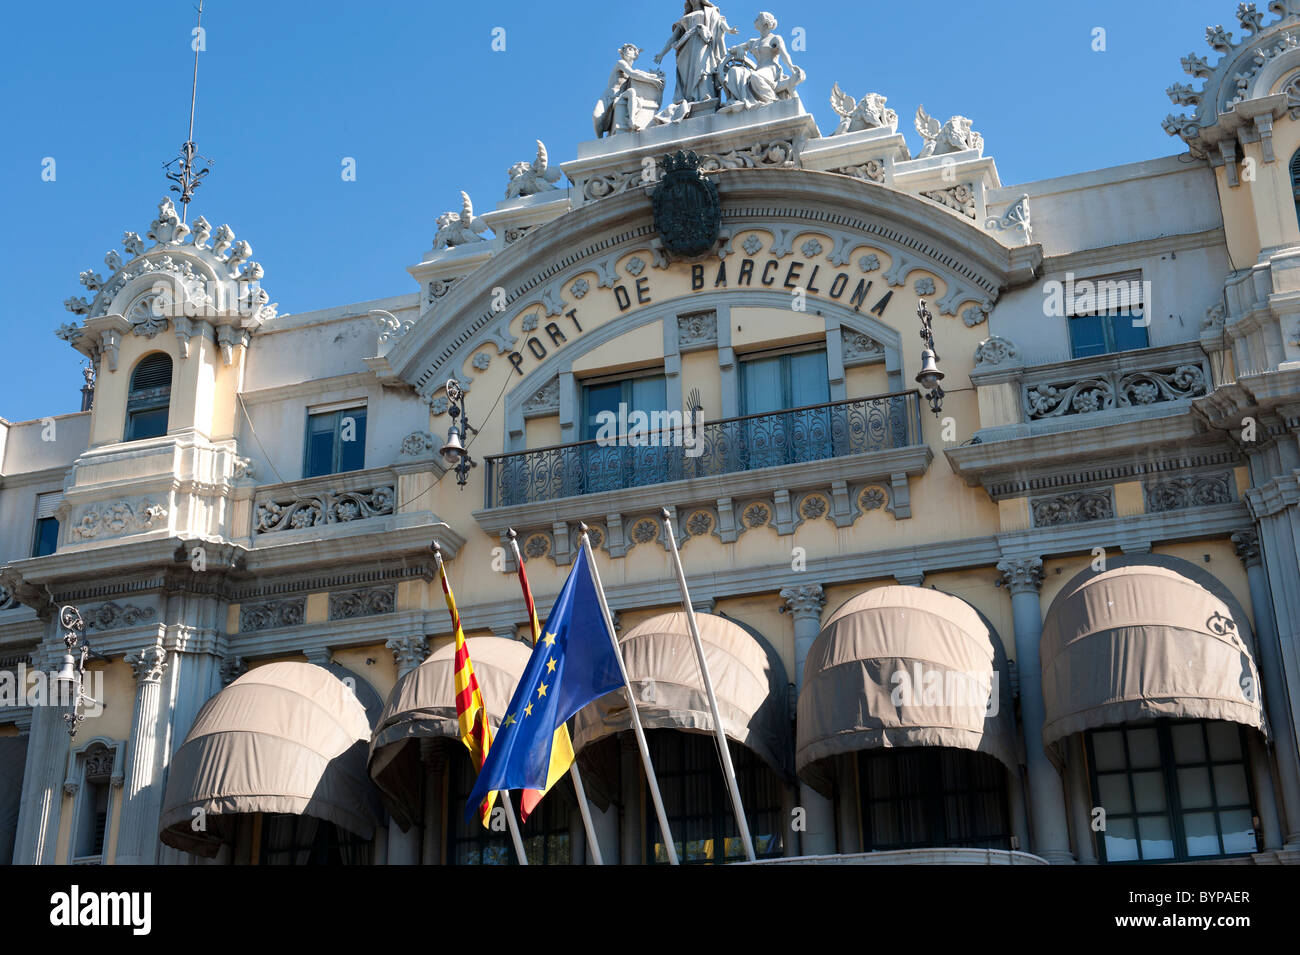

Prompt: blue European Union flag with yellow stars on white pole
[{"left": 465, "top": 548, "right": 624, "bottom": 820}]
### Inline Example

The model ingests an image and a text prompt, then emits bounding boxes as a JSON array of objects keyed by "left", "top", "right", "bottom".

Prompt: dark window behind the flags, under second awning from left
[{"left": 447, "top": 746, "right": 577, "bottom": 865}]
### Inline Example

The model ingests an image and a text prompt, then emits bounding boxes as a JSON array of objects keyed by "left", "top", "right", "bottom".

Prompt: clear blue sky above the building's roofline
[{"left": 0, "top": 0, "right": 1232, "bottom": 421}]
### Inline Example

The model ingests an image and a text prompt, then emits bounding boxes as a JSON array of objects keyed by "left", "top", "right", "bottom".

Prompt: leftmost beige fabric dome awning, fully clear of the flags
[{"left": 160, "top": 663, "right": 378, "bottom": 858}]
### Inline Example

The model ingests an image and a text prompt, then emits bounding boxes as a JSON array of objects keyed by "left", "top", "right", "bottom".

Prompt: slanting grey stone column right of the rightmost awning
[{"left": 1232, "top": 528, "right": 1300, "bottom": 846}]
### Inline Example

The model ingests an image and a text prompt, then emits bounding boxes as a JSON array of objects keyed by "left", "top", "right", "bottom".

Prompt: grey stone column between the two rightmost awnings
[{"left": 997, "top": 557, "right": 1074, "bottom": 864}]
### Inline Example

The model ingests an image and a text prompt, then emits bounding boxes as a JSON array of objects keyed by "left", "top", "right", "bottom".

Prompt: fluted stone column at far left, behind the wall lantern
[{"left": 13, "top": 639, "right": 69, "bottom": 865}]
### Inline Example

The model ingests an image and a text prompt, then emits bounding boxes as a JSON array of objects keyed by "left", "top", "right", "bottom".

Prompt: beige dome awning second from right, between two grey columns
[{"left": 794, "top": 586, "right": 1019, "bottom": 795}]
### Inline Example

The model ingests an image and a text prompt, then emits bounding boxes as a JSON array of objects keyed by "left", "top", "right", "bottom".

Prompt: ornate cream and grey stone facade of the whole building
[{"left": 0, "top": 0, "right": 1300, "bottom": 864}]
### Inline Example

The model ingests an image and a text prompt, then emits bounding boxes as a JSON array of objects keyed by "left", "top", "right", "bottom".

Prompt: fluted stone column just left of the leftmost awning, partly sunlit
[{"left": 114, "top": 643, "right": 168, "bottom": 865}]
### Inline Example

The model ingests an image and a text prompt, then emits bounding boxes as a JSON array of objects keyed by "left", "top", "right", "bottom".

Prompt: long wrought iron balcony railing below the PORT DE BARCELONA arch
[{"left": 486, "top": 391, "right": 920, "bottom": 508}]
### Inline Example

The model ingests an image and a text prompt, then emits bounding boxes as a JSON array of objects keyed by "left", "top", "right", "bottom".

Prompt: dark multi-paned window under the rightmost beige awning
[{"left": 1087, "top": 720, "right": 1257, "bottom": 863}]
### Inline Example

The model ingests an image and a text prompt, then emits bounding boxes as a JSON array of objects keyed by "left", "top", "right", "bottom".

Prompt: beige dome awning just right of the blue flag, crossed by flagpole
[{"left": 573, "top": 613, "right": 793, "bottom": 802}]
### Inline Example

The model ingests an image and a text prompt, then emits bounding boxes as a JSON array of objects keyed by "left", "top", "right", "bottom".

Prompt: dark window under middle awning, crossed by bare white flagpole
[{"left": 645, "top": 730, "right": 785, "bottom": 864}]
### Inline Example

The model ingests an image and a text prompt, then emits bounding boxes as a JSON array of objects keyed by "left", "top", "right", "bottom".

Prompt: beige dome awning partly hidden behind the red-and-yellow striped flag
[{"left": 369, "top": 637, "right": 532, "bottom": 830}]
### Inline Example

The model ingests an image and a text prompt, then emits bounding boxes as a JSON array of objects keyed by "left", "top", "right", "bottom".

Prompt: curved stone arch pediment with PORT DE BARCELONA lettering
[{"left": 385, "top": 169, "right": 1043, "bottom": 399}]
